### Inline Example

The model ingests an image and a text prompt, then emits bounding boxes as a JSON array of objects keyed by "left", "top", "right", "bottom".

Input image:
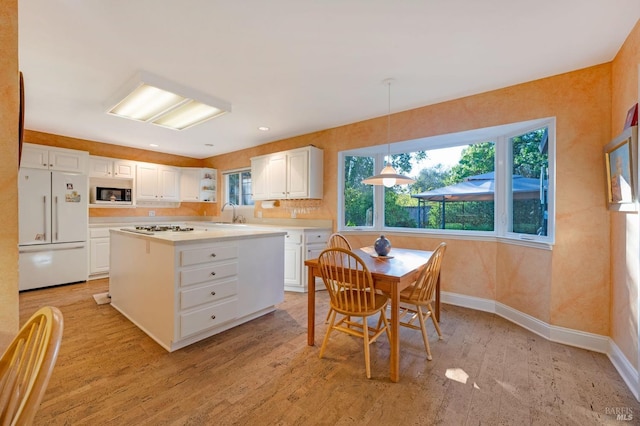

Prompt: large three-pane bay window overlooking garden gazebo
[{"left": 338, "top": 118, "right": 555, "bottom": 243}]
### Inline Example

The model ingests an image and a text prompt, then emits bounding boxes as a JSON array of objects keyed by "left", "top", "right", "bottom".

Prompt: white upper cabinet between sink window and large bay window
[{"left": 251, "top": 146, "right": 323, "bottom": 200}]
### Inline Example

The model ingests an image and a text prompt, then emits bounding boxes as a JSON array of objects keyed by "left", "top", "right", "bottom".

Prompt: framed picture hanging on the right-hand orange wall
[{"left": 604, "top": 126, "right": 638, "bottom": 211}]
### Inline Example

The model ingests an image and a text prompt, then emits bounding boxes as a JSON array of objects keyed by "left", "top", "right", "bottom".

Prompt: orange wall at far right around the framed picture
[{"left": 609, "top": 21, "right": 640, "bottom": 369}]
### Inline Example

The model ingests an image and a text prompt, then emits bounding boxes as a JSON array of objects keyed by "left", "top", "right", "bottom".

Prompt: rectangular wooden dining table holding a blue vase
[{"left": 305, "top": 247, "right": 440, "bottom": 382}]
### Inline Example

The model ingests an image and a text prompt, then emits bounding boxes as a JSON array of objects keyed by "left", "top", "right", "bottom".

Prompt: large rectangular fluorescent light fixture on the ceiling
[{"left": 107, "top": 71, "right": 231, "bottom": 130}]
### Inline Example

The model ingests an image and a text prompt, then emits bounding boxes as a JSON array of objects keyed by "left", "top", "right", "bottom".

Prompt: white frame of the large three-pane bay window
[{"left": 337, "top": 117, "right": 556, "bottom": 249}]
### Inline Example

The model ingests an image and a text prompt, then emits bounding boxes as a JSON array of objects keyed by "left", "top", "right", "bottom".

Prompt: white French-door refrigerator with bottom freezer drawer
[{"left": 18, "top": 168, "right": 89, "bottom": 290}]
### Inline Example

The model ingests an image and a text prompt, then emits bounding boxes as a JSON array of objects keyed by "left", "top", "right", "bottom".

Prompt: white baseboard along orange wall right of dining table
[{"left": 441, "top": 291, "right": 640, "bottom": 401}]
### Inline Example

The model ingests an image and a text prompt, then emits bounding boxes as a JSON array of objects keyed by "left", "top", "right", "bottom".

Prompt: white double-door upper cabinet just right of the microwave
[{"left": 136, "top": 163, "right": 180, "bottom": 202}]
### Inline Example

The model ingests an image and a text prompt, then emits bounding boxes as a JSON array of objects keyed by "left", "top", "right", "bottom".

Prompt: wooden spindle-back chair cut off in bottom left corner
[{"left": 0, "top": 307, "right": 64, "bottom": 425}]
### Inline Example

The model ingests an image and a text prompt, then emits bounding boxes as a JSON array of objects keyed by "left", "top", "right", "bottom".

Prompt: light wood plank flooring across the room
[{"left": 20, "top": 280, "right": 640, "bottom": 426}]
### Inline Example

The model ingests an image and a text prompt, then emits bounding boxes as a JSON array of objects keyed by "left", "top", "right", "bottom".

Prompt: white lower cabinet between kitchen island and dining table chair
[{"left": 284, "top": 228, "right": 331, "bottom": 292}]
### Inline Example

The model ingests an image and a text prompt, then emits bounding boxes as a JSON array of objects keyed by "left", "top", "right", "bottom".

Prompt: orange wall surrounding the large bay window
[{"left": 206, "top": 64, "right": 611, "bottom": 335}]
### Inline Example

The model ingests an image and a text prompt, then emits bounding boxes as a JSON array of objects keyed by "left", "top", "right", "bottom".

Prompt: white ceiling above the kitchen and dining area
[{"left": 19, "top": 0, "right": 640, "bottom": 158}]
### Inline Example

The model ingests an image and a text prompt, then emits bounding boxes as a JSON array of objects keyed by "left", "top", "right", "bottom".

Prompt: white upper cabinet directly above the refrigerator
[{"left": 20, "top": 143, "right": 89, "bottom": 174}]
